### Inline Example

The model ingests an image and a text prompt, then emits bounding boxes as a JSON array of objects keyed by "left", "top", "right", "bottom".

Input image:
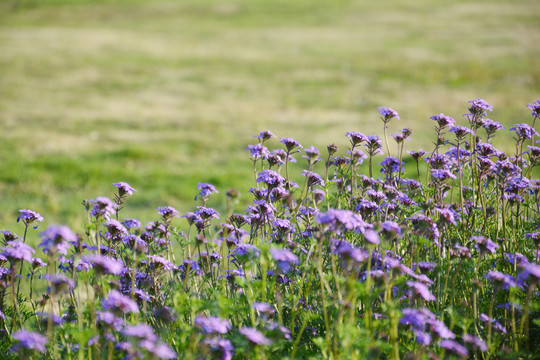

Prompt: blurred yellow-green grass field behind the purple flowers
[{"left": 0, "top": 0, "right": 540, "bottom": 232}]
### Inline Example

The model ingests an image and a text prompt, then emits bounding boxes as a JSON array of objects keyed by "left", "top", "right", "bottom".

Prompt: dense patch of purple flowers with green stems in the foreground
[{"left": 0, "top": 99, "right": 540, "bottom": 359}]
